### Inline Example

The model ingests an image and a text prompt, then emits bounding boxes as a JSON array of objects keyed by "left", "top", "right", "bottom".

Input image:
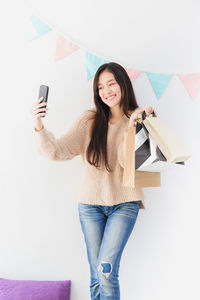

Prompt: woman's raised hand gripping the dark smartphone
[{"left": 30, "top": 97, "right": 48, "bottom": 130}]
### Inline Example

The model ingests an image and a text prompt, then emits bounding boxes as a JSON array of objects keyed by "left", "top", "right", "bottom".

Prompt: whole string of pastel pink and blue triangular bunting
[{"left": 28, "top": 14, "right": 200, "bottom": 100}]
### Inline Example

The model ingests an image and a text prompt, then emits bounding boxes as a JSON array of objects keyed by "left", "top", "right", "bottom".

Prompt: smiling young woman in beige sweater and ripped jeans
[{"left": 31, "top": 62, "right": 153, "bottom": 300}]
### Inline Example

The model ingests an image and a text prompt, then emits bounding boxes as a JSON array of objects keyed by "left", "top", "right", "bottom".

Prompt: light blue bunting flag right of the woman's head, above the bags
[{"left": 146, "top": 72, "right": 173, "bottom": 99}]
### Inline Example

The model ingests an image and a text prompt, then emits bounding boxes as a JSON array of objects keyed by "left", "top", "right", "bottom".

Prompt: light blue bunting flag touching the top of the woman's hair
[{"left": 85, "top": 51, "right": 109, "bottom": 80}]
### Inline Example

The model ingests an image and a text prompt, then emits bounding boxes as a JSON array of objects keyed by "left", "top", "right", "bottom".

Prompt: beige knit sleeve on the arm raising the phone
[{"left": 34, "top": 110, "right": 92, "bottom": 161}]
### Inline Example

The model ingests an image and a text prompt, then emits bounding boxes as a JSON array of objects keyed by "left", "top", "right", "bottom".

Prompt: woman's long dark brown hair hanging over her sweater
[{"left": 86, "top": 62, "right": 138, "bottom": 172}]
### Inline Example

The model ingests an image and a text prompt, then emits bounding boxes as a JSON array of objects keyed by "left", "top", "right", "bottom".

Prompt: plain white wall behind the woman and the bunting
[{"left": 0, "top": 0, "right": 200, "bottom": 300}]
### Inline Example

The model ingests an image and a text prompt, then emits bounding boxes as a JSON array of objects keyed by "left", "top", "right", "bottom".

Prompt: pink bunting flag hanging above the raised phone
[{"left": 54, "top": 34, "right": 79, "bottom": 61}]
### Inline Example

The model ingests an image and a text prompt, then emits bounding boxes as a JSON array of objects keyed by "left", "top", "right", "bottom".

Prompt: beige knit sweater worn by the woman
[{"left": 34, "top": 109, "right": 145, "bottom": 209}]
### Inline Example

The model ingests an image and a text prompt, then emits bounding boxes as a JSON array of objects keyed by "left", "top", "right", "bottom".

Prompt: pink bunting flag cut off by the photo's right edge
[{"left": 178, "top": 74, "right": 200, "bottom": 99}]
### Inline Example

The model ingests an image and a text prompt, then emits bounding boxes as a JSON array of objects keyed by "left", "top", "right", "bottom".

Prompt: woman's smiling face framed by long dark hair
[{"left": 98, "top": 70, "right": 121, "bottom": 107}]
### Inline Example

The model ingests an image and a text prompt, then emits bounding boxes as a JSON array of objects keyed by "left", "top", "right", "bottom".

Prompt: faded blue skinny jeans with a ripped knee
[{"left": 78, "top": 200, "right": 140, "bottom": 300}]
